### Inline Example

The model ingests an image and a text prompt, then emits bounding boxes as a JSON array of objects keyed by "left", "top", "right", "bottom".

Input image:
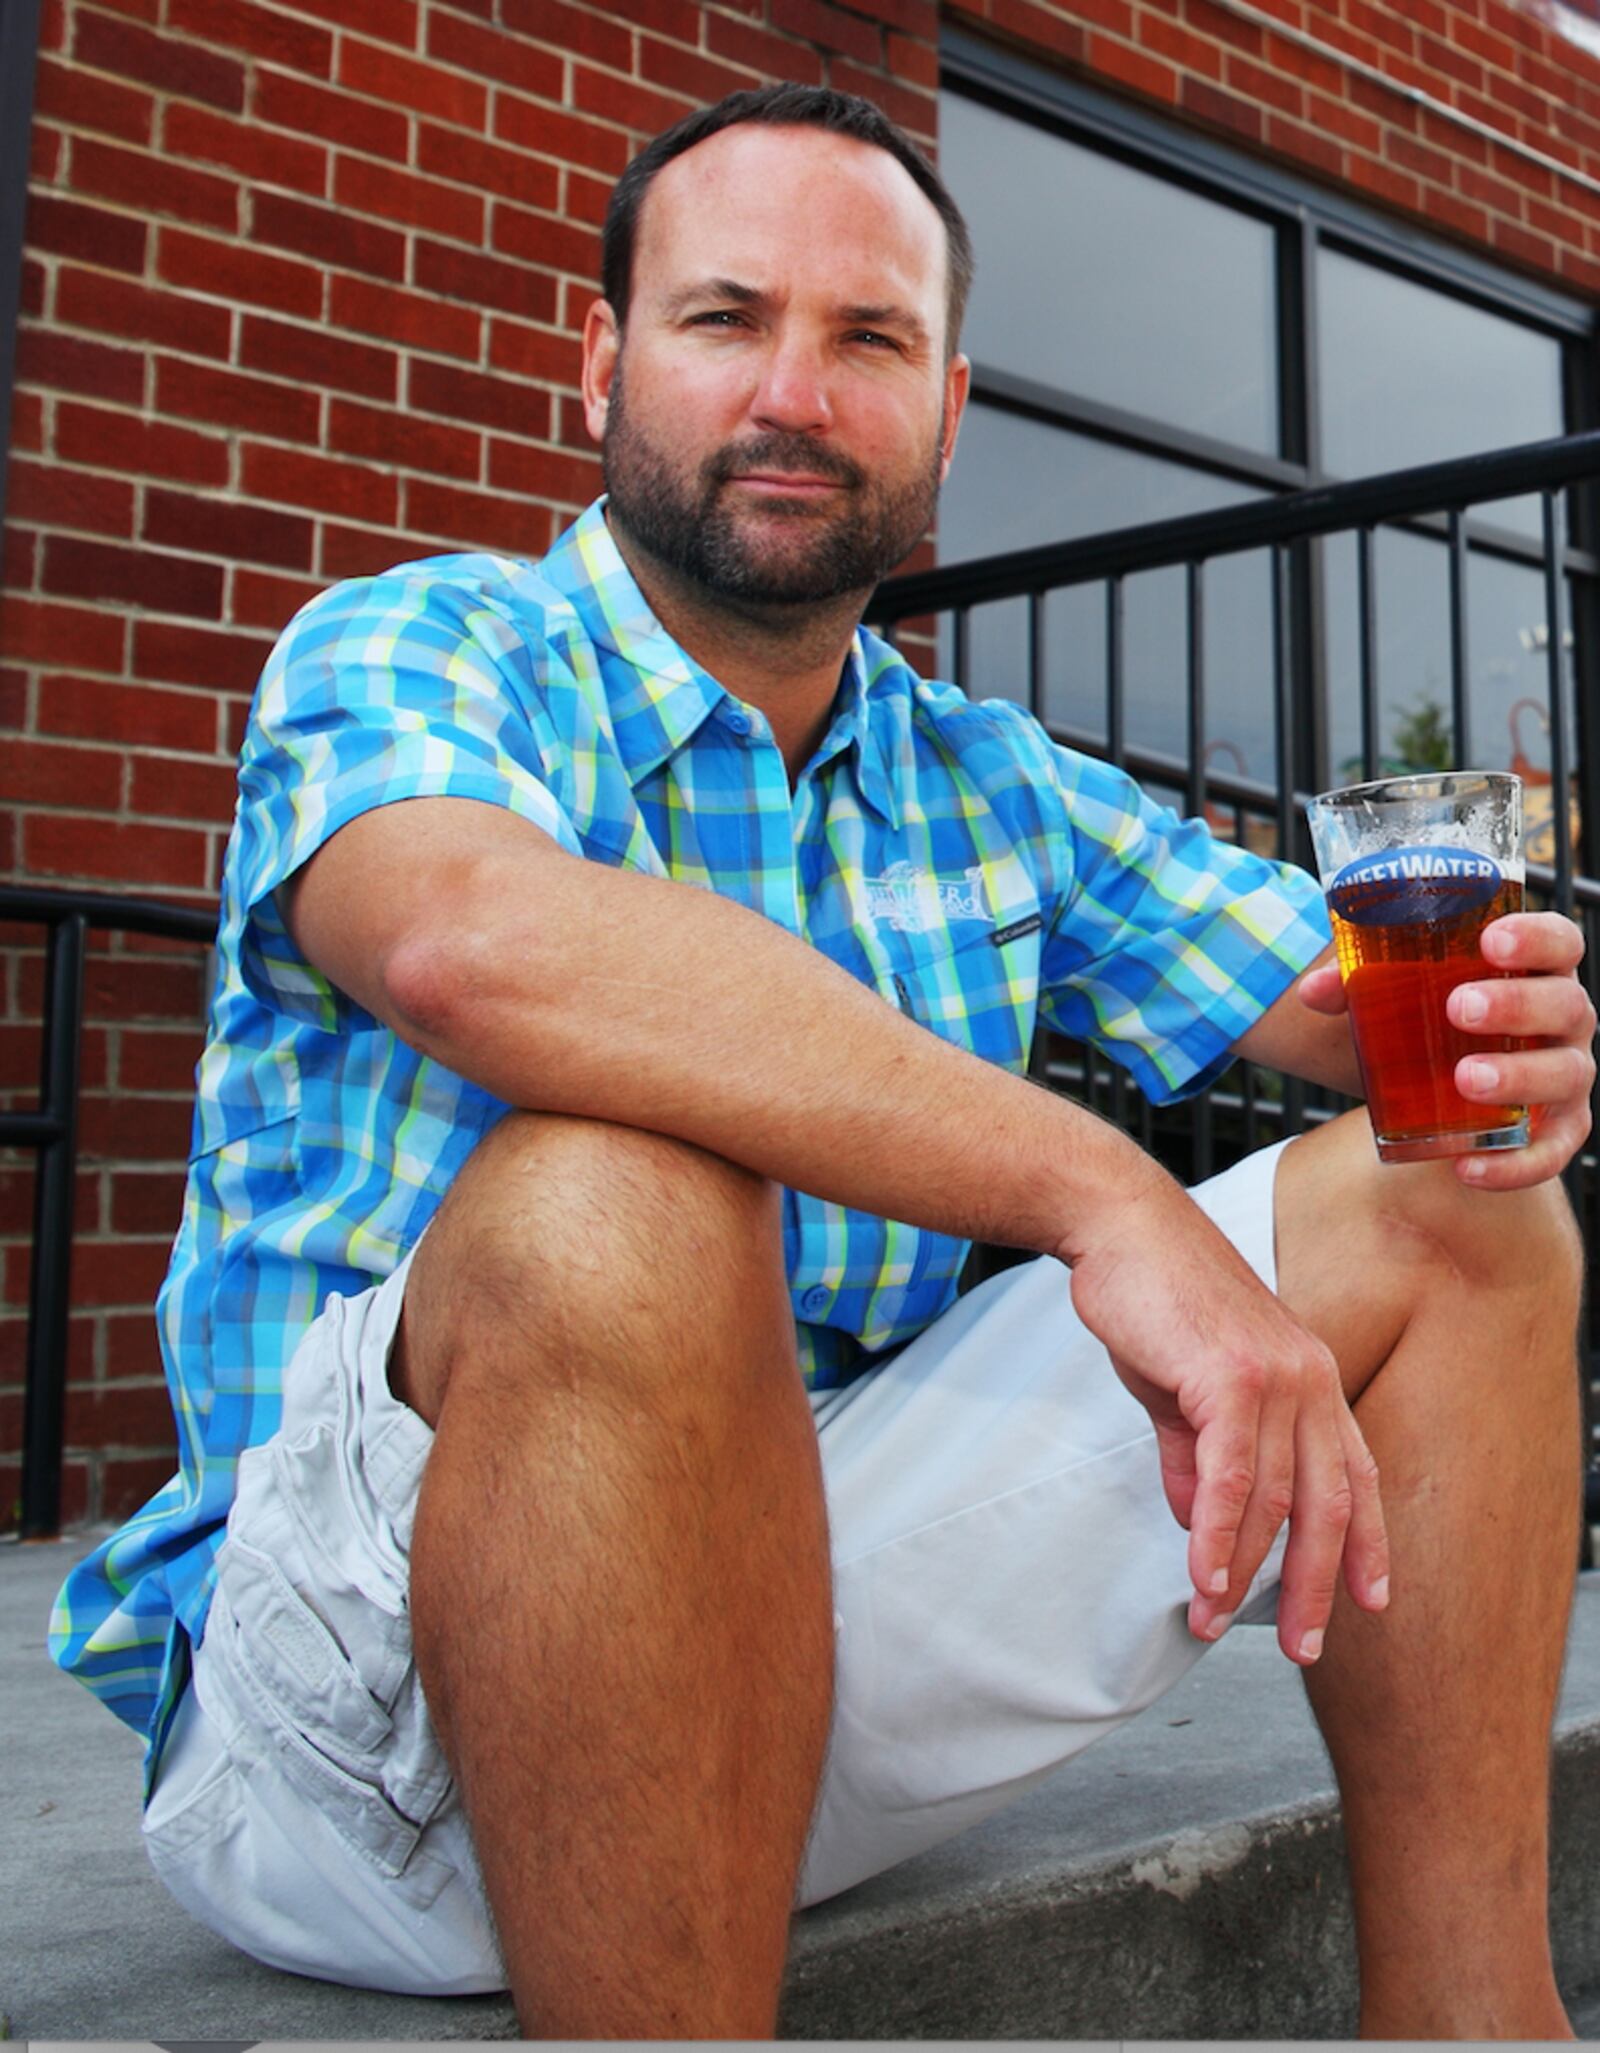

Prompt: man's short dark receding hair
[{"left": 600, "top": 84, "right": 972, "bottom": 351}]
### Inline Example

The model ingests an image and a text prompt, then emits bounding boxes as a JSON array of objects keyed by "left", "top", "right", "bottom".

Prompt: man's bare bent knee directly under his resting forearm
[{"left": 392, "top": 1113, "right": 787, "bottom": 1421}]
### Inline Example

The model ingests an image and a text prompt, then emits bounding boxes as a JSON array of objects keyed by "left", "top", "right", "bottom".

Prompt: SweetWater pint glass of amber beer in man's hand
[{"left": 1310, "top": 770, "right": 1528, "bottom": 1162}]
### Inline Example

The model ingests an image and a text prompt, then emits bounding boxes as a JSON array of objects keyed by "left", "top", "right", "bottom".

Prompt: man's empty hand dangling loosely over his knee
[{"left": 1070, "top": 1166, "right": 1388, "bottom": 1665}]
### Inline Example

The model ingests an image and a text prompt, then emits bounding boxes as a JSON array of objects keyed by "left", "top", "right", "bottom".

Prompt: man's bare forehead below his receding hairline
[{"left": 635, "top": 121, "right": 945, "bottom": 307}]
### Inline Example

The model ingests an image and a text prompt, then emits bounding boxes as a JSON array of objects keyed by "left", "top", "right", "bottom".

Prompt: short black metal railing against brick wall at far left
[{"left": 0, "top": 885, "right": 216, "bottom": 1540}]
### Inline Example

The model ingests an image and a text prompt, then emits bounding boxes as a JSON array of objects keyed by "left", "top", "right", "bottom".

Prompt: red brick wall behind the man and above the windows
[{"left": 0, "top": 0, "right": 1600, "bottom": 1523}]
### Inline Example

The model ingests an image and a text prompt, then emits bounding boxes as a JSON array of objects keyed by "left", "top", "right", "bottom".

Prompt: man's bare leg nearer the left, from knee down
[{"left": 392, "top": 1115, "right": 832, "bottom": 2039}]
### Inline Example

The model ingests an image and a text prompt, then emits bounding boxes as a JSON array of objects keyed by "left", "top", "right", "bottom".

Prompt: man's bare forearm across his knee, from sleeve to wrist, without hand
[{"left": 290, "top": 801, "right": 1167, "bottom": 1256}]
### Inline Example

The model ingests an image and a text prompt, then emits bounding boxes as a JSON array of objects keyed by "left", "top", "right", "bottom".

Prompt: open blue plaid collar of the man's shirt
[{"left": 540, "top": 497, "right": 906, "bottom": 827}]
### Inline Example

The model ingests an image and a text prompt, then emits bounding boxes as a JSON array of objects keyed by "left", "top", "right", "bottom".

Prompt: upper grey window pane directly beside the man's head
[{"left": 939, "top": 92, "right": 1278, "bottom": 454}]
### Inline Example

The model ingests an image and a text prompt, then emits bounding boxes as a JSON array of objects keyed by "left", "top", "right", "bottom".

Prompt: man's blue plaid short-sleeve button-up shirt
[{"left": 51, "top": 501, "right": 1327, "bottom": 1766}]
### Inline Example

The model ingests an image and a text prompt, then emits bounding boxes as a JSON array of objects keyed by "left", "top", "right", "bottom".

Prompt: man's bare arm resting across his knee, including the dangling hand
[{"left": 283, "top": 799, "right": 1386, "bottom": 1659}]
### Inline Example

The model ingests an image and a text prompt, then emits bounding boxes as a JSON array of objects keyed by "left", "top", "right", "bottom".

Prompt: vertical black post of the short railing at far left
[{"left": 21, "top": 914, "right": 88, "bottom": 1540}]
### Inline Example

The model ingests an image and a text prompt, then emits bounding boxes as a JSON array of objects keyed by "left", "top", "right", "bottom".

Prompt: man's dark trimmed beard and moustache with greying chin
[{"left": 602, "top": 365, "right": 945, "bottom": 606}]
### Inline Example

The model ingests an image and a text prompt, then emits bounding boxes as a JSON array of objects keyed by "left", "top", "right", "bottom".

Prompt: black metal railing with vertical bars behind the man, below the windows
[{"left": 869, "top": 433, "right": 1600, "bottom": 1486}]
